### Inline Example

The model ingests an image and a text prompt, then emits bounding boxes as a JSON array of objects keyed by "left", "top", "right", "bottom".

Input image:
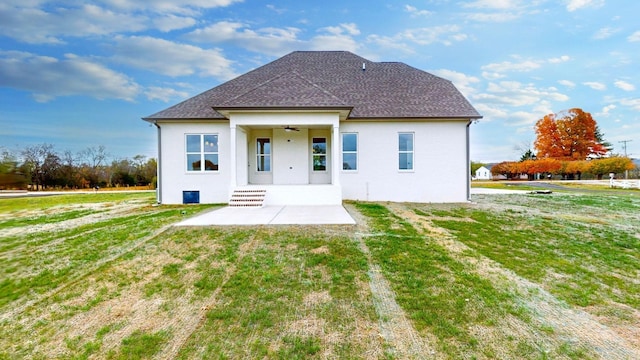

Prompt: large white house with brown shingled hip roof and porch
[{"left": 143, "top": 51, "right": 481, "bottom": 205}]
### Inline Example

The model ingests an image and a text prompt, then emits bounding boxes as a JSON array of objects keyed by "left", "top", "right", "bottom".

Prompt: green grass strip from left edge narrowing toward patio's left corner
[{"left": 0, "top": 208, "right": 209, "bottom": 309}]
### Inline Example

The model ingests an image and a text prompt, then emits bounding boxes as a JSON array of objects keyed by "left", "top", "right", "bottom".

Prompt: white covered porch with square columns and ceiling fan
[{"left": 226, "top": 110, "right": 348, "bottom": 205}]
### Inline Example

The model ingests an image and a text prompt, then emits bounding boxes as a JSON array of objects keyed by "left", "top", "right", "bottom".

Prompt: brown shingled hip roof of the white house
[{"left": 144, "top": 51, "right": 481, "bottom": 121}]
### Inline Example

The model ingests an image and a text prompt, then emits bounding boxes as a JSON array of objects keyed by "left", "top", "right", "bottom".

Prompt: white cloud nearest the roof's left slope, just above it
[{"left": 112, "top": 36, "right": 236, "bottom": 80}]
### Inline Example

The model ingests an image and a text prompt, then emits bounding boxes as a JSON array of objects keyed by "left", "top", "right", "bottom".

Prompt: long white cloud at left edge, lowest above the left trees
[{"left": 0, "top": 51, "right": 140, "bottom": 102}]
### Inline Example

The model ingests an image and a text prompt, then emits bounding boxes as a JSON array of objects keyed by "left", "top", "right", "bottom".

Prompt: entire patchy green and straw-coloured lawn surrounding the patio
[{"left": 0, "top": 192, "right": 640, "bottom": 359}]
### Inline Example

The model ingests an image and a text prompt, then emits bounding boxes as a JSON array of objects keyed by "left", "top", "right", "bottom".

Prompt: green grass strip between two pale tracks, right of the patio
[{"left": 357, "top": 204, "right": 556, "bottom": 358}]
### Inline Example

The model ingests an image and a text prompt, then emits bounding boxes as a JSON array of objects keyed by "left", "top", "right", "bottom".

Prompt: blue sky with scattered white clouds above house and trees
[{"left": 0, "top": 0, "right": 640, "bottom": 162}]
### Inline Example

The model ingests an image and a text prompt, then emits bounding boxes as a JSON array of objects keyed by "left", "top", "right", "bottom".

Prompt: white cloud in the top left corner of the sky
[{"left": 0, "top": 5, "right": 148, "bottom": 44}]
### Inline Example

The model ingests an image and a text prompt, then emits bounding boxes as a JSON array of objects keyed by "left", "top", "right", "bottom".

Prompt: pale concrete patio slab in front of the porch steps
[{"left": 176, "top": 205, "right": 356, "bottom": 226}]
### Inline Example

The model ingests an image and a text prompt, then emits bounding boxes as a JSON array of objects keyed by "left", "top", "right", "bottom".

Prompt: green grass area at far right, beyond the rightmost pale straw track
[{"left": 433, "top": 196, "right": 640, "bottom": 308}]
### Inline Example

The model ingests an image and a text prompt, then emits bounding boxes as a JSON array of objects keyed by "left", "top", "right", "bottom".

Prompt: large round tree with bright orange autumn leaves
[{"left": 534, "top": 108, "right": 608, "bottom": 160}]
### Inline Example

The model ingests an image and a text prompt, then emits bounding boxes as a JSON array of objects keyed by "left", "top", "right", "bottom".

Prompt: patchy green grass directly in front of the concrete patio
[{"left": 179, "top": 228, "right": 374, "bottom": 359}]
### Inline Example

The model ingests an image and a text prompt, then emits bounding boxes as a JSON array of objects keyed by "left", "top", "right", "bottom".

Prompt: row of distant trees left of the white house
[{"left": 0, "top": 143, "right": 157, "bottom": 190}]
